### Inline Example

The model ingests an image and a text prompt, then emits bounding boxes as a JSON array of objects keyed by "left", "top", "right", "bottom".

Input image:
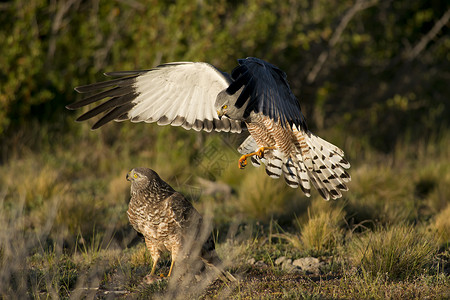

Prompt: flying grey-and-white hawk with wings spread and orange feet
[{"left": 67, "top": 57, "right": 350, "bottom": 200}]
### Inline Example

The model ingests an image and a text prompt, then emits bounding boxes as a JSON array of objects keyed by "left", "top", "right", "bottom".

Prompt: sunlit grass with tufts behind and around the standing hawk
[{"left": 0, "top": 123, "right": 450, "bottom": 299}]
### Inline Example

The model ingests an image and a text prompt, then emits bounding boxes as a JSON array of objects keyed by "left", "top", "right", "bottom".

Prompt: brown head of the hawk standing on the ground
[{"left": 126, "top": 168, "right": 174, "bottom": 199}]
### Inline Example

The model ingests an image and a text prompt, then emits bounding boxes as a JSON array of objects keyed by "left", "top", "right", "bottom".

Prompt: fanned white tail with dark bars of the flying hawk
[{"left": 238, "top": 127, "right": 351, "bottom": 200}]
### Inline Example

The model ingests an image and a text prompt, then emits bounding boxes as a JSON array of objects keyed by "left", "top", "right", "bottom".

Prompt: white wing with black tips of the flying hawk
[{"left": 67, "top": 62, "right": 245, "bottom": 132}]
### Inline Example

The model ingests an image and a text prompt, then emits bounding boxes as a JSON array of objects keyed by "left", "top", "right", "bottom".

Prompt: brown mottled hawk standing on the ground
[{"left": 127, "top": 168, "right": 235, "bottom": 281}]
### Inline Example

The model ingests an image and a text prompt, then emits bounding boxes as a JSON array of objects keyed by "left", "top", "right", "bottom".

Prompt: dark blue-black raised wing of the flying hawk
[{"left": 227, "top": 57, "right": 307, "bottom": 131}]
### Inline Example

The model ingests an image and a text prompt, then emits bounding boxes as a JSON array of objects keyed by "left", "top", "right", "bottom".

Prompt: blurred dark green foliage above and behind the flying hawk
[{"left": 0, "top": 0, "right": 450, "bottom": 150}]
